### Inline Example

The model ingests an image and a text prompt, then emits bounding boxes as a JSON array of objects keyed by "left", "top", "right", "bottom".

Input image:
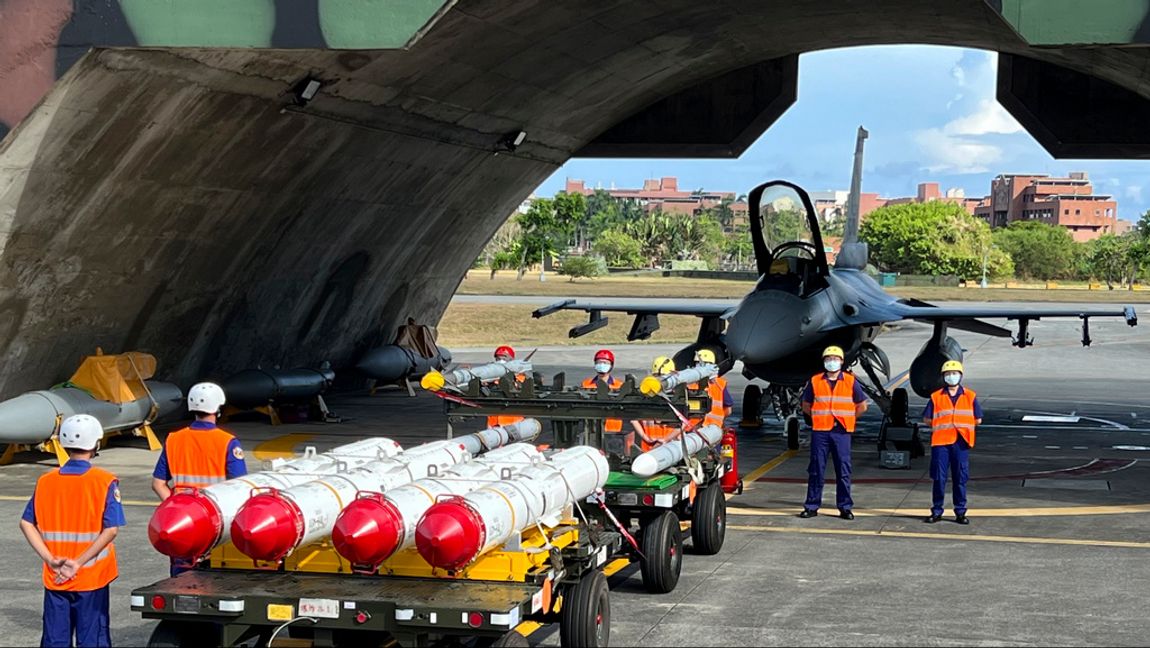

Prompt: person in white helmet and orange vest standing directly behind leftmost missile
[{"left": 152, "top": 382, "right": 247, "bottom": 575}]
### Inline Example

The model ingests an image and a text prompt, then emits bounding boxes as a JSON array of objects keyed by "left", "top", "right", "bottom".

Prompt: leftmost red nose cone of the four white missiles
[{"left": 147, "top": 493, "right": 223, "bottom": 559}]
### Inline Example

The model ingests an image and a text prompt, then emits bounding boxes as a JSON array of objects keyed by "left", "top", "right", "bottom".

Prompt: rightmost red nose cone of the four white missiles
[{"left": 415, "top": 501, "right": 486, "bottom": 570}]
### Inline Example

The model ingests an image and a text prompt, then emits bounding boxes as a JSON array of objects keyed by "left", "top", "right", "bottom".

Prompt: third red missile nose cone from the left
[{"left": 331, "top": 497, "right": 404, "bottom": 569}]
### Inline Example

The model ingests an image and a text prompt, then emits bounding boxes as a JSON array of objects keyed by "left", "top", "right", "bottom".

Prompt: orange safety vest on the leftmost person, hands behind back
[{"left": 35, "top": 466, "right": 120, "bottom": 592}]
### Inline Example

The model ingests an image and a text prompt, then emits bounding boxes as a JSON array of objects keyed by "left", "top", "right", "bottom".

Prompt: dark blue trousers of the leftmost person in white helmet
[{"left": 40, "top": 585, "right": 112, "bottom": 648}]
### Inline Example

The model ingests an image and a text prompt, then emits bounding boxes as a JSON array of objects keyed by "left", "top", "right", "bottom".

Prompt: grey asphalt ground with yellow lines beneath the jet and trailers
[{"left": 0, "top": 299, "right": 1150, "bottom": 646}]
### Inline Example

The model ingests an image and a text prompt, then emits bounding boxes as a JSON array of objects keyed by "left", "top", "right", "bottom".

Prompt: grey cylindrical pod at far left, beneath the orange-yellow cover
[{"left": 0, "top": 380, "right": 183, "bottom": 443}]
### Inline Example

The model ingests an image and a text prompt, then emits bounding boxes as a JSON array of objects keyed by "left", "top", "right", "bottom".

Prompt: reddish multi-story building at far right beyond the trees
[{"left": 975, "top": 171, "right": 1128, "bottom": 242}]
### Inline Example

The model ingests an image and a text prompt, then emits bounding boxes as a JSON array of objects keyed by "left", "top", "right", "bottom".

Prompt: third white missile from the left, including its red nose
[{"left": 331, "top": 443, "right": 543, "bottom": 572}]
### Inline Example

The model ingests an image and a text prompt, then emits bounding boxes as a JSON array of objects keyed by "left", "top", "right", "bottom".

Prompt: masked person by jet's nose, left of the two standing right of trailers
[{"left": 798, "top": 346, "right": 866, "bottom": 520}]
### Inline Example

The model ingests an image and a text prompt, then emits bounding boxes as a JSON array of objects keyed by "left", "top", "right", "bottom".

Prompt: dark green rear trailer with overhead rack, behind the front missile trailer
[{"left": 444, "top": 373, "right": 730, "bottom": 594}]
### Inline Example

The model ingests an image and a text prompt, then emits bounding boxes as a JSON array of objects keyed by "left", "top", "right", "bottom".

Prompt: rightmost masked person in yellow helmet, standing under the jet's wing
[{"left": 922, "top": 360, "right": 982, "bottom": 524}]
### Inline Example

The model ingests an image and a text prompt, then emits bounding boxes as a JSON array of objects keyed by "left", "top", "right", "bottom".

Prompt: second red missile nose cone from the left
[{"left": 231, "top": 494, "right": 304, "bottom": 561}]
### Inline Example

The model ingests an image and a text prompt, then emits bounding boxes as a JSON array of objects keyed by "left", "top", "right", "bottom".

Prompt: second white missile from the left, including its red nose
[{"left": 231, "top": 424, "right": 538, "bottom": 561}]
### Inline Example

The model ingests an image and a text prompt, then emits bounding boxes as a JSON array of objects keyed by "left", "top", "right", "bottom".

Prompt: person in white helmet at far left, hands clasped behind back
[{"left": 20, "top": 414, "right": 125, "bottom": 647}]
